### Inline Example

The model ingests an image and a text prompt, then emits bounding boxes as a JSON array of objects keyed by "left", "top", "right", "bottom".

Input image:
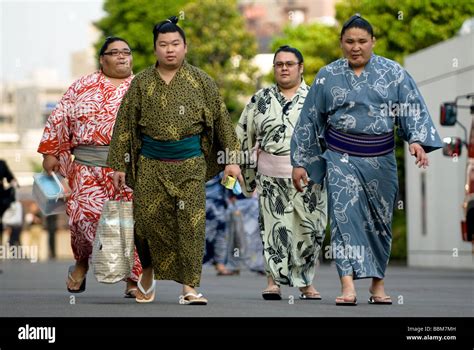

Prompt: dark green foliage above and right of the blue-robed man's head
[{"left": 336, "top": 0, "right": 474, "bottom": 64}]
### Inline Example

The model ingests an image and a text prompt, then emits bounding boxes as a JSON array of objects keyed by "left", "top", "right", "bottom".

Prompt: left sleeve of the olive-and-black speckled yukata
[{"left": 107, "top": 77, "right": 141, "bottom": 174}]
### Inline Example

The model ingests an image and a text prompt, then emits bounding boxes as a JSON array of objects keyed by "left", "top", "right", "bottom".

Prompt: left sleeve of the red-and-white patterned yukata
[{"left": 37, "top": 82, "right": 78, "bottom": 177}]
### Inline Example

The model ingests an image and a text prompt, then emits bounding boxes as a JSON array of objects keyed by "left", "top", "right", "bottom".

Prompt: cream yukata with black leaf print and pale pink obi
[{"left": 237, "top": 81, "right": 327, "bottom": 287}]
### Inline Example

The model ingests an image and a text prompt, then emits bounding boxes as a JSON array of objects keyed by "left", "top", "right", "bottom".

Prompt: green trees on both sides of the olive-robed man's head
[{"left": 96, "top": 0, "right": 257, "bottom": 119}]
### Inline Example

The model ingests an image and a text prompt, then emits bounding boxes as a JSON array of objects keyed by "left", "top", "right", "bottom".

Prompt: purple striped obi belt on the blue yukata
[{"left": 324, "top": 127, "right": 395, "bottom": 157}]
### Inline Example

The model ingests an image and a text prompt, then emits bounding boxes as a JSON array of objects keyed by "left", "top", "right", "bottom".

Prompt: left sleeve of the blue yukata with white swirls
[{"left": 291, "top": 70, "right": 327, "bottom": 184}]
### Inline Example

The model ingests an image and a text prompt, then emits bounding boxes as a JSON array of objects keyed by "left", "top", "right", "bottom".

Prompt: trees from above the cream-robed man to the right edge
[{"left": 272, "top": 0, "right": 474, "bottom": 84}]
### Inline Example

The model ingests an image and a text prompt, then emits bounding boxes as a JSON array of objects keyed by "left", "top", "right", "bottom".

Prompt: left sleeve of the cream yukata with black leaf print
[{"left": 235, "top": 95, "right": 257, "bottom": 197}]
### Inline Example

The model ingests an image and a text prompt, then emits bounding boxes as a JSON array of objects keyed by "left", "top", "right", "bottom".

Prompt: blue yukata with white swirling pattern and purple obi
[{"left": 291, "top": 55, "right": 442, "bottom": 279}]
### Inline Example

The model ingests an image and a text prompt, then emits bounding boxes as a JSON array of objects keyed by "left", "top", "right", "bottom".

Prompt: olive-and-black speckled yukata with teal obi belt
[{"left": 108, "top": 62, "right": 239, "bottom": 287}]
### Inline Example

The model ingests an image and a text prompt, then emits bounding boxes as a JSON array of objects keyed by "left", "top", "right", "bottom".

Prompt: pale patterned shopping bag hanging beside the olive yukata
[{"left": 92, "top": 191, "right": 135, "bottom": 283}]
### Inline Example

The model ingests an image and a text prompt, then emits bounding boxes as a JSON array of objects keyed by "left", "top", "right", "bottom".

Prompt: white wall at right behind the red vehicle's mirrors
[{"left": 405, "top": 33, "right": 474, "bottom": 269}]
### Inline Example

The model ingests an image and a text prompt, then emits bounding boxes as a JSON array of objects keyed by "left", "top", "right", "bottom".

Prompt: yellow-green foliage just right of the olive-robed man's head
[{"left": 185, "top": 0, "right": 257, "bottom": 120}]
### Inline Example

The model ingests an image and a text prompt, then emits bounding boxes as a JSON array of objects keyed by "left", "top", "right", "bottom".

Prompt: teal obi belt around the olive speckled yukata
[{"left": 140, "top": 134, "right": 202, "bottom": 161}]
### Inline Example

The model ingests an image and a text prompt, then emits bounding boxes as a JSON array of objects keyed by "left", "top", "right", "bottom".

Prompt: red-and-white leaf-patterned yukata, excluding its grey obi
[{"left": 38, "top": 71, "right": 141, "bottom": 281}]
